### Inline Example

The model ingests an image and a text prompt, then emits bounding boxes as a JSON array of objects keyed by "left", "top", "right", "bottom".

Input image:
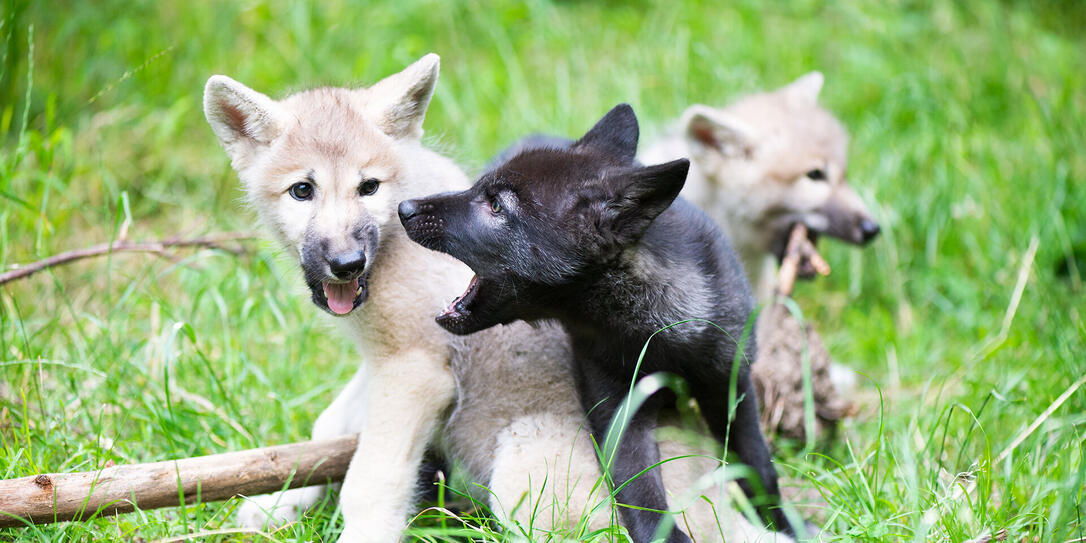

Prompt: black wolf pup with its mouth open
[{"left": 399, "top": 104, "right": 787, "bottom": 542}]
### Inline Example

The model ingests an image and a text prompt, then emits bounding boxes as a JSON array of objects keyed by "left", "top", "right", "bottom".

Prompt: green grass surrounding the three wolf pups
[{"left": 0, "top": 0, "right": 1086, "bottom": 542}]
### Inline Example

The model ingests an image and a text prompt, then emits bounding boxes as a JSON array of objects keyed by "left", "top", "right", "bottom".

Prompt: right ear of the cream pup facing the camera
[{"left": 357, "top": 53, "right": 441, "bottom": 139}]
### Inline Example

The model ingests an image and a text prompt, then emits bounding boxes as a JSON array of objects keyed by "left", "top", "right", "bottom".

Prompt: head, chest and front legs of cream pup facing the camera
[{"left": 204, "top": 55, "right": 470, "bottom": 542}]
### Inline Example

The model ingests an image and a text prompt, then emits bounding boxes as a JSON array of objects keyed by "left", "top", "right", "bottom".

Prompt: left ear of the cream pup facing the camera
[{"left": 204, "top": 75, "right": 283, "bottom": 168}]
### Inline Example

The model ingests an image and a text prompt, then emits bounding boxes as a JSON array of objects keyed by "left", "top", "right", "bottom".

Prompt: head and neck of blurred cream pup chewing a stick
[{"left": 642, "top": 72, "right": 879, "bottom": 301}]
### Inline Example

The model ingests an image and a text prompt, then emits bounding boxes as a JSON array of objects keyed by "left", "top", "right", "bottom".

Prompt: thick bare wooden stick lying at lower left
[{"left": 0, "top": 435, "right": 357, "bottom": 528}]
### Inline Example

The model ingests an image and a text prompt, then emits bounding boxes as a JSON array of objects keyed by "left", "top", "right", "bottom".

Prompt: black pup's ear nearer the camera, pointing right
[{"left": 602, "top": 159, "right": 690, "bottom": 244}]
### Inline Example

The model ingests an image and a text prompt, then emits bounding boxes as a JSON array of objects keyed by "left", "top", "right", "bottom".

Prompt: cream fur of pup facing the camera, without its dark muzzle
[{"left": 204, "top": 54, "right": 786, "bottom": 543}]
